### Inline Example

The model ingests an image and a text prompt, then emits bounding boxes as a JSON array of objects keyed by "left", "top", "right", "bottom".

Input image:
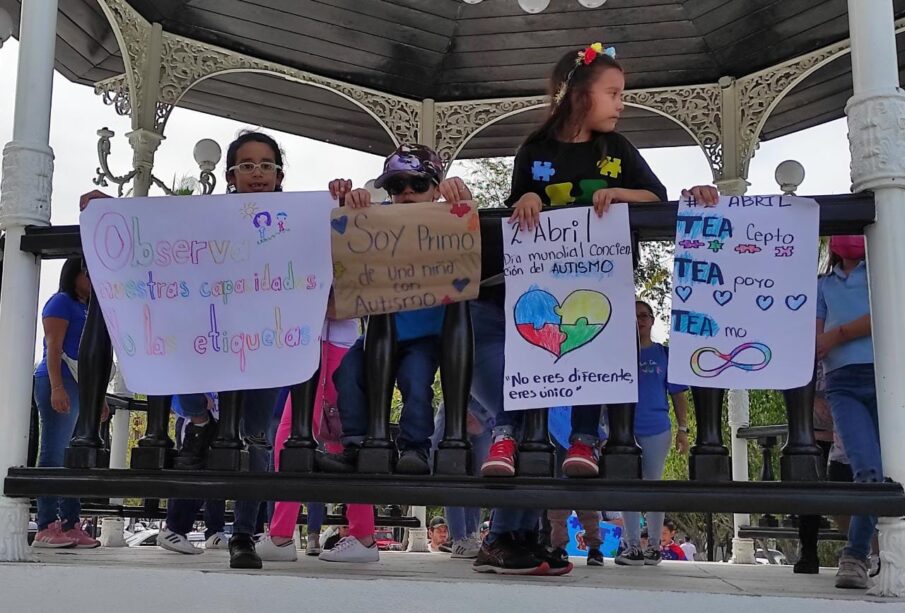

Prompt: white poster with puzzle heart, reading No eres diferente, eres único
[{"left": 502, "top": 204, "right": 638, "bottom": 411}]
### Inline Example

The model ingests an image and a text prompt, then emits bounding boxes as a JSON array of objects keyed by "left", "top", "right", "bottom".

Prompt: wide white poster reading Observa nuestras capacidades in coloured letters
[{"left": 80, "top": 192, "right": 335, "bottom": 395}]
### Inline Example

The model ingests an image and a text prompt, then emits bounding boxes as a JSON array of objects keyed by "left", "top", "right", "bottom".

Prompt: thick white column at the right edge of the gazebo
[{"left": 845, "top": 0, "right": 905, "bottom": 597}]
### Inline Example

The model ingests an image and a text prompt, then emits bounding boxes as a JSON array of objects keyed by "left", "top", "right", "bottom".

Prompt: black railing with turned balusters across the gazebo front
[{"left": 4, "top": 194, "right": 905, "bottom": 515}]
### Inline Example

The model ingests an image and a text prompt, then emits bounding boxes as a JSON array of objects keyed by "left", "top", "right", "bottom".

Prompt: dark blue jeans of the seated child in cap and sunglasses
[{"left": 333, "top": 336, "right": 440, "bottom": 451}]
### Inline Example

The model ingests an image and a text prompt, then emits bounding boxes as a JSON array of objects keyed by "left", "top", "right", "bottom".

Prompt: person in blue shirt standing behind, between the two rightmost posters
[{"left": 616, "top": 300, "right": 688, "bottom": 566}]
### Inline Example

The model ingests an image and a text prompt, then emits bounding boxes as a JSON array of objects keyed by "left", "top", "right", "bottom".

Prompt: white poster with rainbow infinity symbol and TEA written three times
[{"left": 669, "top": 196, "right": 819, "bottom": 389}]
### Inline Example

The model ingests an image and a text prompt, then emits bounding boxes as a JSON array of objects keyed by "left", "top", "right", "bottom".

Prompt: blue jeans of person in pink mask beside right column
[{"left": 826, "top": 364, "right": 883, "bottom": 560}]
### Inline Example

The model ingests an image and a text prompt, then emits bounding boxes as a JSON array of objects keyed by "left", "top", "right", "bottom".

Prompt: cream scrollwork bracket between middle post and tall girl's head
[{"left": 434, "top": 96, "right": 550, "bottom": 165}]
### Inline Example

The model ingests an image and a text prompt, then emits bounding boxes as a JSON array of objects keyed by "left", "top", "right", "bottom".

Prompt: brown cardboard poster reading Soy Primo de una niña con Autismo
[{"left": 330, "top": 202, "right": 481, "bottom": 318}]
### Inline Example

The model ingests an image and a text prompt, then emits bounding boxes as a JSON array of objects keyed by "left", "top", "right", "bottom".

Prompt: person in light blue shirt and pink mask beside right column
[{"left": 817, "top": 236, "right": 883, "bottom": 589}]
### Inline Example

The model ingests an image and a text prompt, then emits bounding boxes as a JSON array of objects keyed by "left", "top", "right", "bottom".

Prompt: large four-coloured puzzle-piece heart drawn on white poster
[{"left": 515, "top": 289, "right": 613, "bottom": 360}]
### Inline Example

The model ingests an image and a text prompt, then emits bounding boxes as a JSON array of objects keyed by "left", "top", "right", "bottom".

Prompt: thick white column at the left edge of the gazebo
[{"left": 0, "top": 0, "right": 57, "bottom": 562}]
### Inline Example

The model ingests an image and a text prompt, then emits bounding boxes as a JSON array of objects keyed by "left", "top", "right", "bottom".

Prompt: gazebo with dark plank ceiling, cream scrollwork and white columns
[{"left": 0, "top": 0, "right": 905, "bottom": 595}]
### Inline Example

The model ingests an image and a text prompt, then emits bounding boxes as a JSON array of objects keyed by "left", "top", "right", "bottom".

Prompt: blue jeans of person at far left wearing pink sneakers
[{"left": 34, "top": 375, "right": 82, "bottom": 530}]
